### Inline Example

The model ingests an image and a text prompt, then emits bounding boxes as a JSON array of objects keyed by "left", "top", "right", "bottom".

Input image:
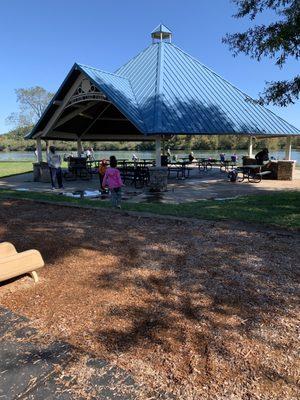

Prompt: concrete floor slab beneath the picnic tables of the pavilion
[{"left": 0, "top": 168, "right": 300, "bottom": 203}]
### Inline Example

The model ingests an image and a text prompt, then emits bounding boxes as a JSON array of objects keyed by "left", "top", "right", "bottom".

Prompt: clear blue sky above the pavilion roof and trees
[{"left": 0, "top": 0, "right": 300, "bottom": 133}]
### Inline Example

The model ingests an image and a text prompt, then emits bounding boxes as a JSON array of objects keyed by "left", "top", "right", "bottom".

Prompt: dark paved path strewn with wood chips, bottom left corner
[{"left": 0, "top": 306, "right": 170, "bottom": 400}]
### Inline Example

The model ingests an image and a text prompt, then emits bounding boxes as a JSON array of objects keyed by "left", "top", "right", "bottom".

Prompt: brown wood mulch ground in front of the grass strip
[{"left": 0, "top": 200, "right": 300, "bottom": 400}]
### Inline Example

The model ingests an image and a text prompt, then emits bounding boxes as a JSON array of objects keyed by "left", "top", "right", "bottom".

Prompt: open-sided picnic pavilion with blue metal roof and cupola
[{"left": 27, "top": 25, "right": 300, "bottom": 167}]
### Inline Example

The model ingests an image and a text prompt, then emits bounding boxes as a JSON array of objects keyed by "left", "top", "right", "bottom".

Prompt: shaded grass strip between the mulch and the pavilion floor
[{"left": 0, "top": 190, "right": 300, "bottom": 228}]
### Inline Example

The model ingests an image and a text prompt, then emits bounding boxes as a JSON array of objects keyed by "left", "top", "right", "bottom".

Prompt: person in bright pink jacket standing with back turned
[{"left": 102, "top": 156, "right": 123, "bottom": 208}]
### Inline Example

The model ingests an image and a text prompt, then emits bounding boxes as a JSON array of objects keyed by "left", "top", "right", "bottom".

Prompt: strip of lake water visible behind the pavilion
[{"left": 0, "top": 150, "right": 300, "bottom": 166}]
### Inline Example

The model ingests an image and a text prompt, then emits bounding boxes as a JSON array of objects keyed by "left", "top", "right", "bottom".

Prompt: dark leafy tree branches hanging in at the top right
[{"left": 222, "top": 0, "right": 300, "bottom": 106}]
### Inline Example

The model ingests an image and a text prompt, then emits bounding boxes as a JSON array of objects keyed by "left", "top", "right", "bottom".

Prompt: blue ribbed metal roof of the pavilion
[{"left": 30, "top": 30, "right": 300, "bottom": 137}]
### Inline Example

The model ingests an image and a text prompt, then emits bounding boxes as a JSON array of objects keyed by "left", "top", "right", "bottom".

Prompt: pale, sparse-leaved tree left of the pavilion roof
[{"left": 6, "top": 86, "right": 53, "bottom": 127}]
